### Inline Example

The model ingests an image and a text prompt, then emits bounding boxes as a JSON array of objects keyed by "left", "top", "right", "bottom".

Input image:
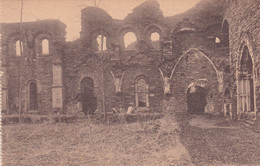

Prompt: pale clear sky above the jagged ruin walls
[{"left": 0, "top": 0, "right": 200, "bottom": 41}]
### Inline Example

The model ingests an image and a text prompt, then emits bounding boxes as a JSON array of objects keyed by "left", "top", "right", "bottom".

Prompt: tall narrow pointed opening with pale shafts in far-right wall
[{"left": 238, "top": 46, "right": 254, "bottom": 113}]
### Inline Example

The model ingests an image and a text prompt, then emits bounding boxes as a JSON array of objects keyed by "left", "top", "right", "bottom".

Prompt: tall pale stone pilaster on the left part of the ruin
[{"left": 52, "top": 59, "right": 63, "bottom": 111}]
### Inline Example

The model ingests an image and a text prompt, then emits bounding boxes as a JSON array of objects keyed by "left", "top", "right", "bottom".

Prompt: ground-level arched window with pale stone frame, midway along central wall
[{"left": 135, "top": 76, "right": 149, "bottom": 107}]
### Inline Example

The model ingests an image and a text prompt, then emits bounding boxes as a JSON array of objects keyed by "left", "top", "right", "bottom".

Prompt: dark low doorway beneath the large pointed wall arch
[{"left": 187, "top": 86, "right": 207, "bottom": 114}]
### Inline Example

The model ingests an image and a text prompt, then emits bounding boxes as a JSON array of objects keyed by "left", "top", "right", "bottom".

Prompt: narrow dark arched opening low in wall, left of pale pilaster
[{"left": 28, "top": 81, "right": 38, "bottom": 110}]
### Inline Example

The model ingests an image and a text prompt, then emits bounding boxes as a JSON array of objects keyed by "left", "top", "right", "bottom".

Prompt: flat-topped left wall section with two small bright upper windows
[{"left": 1, "top": 20, "right": 65, "bottom": 114}]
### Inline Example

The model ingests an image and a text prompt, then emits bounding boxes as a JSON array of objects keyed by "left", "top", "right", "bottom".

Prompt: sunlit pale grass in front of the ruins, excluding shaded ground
[{"left": 2, "top": 118, "right": 190, "bottom": 166}]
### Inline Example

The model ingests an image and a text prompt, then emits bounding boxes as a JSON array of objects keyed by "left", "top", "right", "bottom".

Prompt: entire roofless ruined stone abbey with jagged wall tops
[{"left": 0, "top": 0, "right": 260, "bottom": 119}]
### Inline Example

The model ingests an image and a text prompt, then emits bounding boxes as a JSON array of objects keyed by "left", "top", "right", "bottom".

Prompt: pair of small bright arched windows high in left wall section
[{"left": 15, "top": 39, "right": 50, "bottom": 56}]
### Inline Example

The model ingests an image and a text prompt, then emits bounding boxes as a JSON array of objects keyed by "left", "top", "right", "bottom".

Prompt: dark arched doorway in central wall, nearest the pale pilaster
[{"left": 81, "top": 77, "right": 97, "bottom": 115}]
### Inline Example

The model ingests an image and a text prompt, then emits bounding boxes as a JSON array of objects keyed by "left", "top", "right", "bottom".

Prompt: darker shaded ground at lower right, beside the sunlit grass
[{"left": 178, "top": 116, "right": 260, "bottom": 165}]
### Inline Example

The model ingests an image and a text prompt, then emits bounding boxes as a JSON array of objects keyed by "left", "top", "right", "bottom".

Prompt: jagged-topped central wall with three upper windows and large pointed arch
[{"left": 63, "top": 1, "right": 228, "bottom": 113}]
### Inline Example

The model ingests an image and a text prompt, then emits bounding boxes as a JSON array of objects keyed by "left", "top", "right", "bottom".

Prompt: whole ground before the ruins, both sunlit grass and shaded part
[{"left": 2, "top": 115, "right": 260, "bottom": 166}]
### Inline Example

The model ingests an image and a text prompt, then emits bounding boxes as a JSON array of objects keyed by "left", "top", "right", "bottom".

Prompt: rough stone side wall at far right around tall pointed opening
[{"left": 224, "top": 0, "right": 260, "bottom": 116}]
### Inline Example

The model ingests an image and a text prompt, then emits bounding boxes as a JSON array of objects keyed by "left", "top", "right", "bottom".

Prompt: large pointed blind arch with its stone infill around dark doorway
[{"left": 170, "top": 49, "right": 219, "bottom": 114}]
